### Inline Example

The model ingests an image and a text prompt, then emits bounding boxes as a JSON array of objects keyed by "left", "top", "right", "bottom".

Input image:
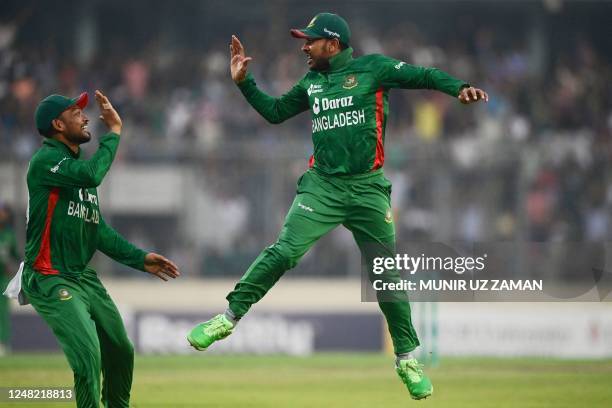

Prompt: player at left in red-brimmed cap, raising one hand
[{"left": 9, "top": 91, "right": 179, "bottom": 408}]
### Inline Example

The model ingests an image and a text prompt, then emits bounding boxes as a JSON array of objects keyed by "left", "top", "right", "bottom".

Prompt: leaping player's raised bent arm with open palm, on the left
[{"left": 230, "top": 36, "right": 309, "bottom": 123}]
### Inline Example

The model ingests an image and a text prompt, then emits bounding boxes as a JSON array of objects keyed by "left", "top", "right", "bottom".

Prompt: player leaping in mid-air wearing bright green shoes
[{"left": 187, "top": 13, "right": 488, "bottom": 399}]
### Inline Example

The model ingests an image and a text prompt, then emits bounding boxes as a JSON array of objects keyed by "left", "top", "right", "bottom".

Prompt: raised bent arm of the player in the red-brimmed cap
[{"left": 30, "top": 91, "right": 123, "bottom": 187}]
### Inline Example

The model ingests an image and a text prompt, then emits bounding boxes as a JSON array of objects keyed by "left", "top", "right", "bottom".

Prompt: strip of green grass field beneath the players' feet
[{"left": 0, "top": 353, "right": 612, "bottom": 408}]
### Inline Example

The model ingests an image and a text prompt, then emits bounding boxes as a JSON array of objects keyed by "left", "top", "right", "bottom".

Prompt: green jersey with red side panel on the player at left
[{"left": 25, "top": 133, "right": 146, "bottom": 275}]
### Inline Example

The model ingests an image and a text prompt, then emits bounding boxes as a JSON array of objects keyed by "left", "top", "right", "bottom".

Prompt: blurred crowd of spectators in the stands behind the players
[{"left": 0, "top": 2, "right": 612, "bottom": 274}]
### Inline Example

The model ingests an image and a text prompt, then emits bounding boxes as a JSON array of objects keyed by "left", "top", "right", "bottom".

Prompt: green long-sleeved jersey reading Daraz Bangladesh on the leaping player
[{"left": 238, "top": 48, "right": 469, "bottom": 175}]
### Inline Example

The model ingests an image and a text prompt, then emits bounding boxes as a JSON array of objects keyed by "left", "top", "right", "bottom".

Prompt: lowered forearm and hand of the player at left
[{"left": 97, "top": 217, "right": 180, "bottom": 281}]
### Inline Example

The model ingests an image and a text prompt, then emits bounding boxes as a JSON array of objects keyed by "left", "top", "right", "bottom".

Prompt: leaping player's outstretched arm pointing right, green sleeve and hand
[{"left": 376, "top": 55, "right": 489, "bottom": 104}]
